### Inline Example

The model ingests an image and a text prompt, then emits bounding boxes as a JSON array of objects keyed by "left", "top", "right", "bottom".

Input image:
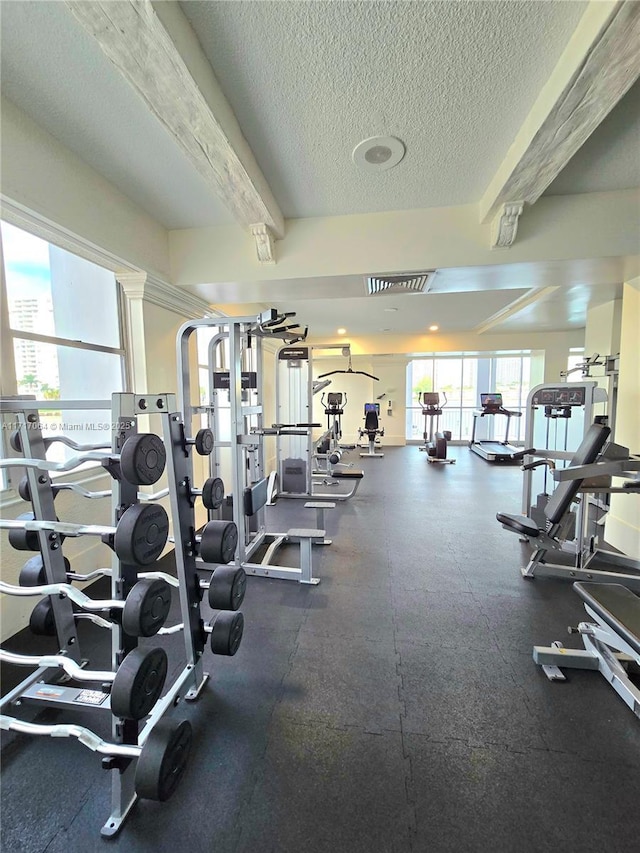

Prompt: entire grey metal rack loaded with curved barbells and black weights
[{"left": 0, "top": 393, "right": 245, "bottom": 837}]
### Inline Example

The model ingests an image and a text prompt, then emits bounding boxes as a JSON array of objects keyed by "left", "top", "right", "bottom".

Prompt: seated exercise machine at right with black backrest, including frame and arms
[{"left": 496, "top": 423, "right": 640, "bottom": 590}]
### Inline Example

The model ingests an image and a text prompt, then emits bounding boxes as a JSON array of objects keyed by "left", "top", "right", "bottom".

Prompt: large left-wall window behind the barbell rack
[{"left": 0, "top": 222, "right": 125, "bottom": 486}]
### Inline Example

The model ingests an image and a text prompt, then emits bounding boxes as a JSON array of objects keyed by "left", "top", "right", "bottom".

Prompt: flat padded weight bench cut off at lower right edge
[{"left": 533, "top": 583, "right": 640, "bottom": 718}]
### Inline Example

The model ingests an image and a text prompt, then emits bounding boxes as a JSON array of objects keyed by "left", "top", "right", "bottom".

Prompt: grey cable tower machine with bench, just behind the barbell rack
[{"left": 177, "top": 309, "right": 333, "bottom": 584}]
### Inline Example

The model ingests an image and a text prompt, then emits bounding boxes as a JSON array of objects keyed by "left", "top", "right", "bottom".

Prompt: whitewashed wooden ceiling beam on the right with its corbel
[{"left": 480, "top": 0, "right": 640, "bottom": 236}]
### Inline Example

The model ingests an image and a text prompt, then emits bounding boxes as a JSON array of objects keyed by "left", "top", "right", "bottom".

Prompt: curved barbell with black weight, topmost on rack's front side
[{"left": 0, "top": 432, "right": 167, "bottom": 486}]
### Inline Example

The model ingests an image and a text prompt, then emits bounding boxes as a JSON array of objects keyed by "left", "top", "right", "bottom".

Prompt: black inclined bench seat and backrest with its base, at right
[{"left": 496, "top": 424, "right": 640, "bottom": 590}]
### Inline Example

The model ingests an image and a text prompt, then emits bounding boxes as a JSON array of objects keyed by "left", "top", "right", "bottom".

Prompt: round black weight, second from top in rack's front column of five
[{"left": 114, "top": 504, "right": 169, "bottom": 566}]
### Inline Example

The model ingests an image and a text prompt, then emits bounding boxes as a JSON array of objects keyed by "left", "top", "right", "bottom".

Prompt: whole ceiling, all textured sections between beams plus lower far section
[{"left": 0, "top": 0, "right": 640, "bottom": 336}]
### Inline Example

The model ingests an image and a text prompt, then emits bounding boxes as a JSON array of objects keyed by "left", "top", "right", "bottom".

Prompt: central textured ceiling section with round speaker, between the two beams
[{"left": 181, "top": 0, "right": 587, "bottom": 217}]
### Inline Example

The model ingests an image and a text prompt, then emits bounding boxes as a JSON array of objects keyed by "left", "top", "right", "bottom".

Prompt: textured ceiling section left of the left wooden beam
[{"left": 0, "top": 0, "right": 234, "bottom": 228}]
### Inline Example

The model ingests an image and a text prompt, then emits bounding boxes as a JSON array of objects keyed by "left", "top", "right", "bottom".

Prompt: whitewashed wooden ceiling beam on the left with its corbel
[{"left": 66, "top": 0, "right": 284, "bottom": 246}]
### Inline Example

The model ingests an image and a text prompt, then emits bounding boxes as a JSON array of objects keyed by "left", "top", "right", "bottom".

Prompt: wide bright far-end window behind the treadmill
[{"left": 406, "top": 353, "right": 531, "bottom": 441}]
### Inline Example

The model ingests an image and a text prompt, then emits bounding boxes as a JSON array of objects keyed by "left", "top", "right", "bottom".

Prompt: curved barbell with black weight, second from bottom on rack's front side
[{"left": 0, "top": 646, "right": 168, "bottom": 720}]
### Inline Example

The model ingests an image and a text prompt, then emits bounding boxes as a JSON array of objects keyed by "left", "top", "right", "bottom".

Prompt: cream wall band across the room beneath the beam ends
[{"left": 169, "top": 190, "right": 640, "bottom": 284}]
